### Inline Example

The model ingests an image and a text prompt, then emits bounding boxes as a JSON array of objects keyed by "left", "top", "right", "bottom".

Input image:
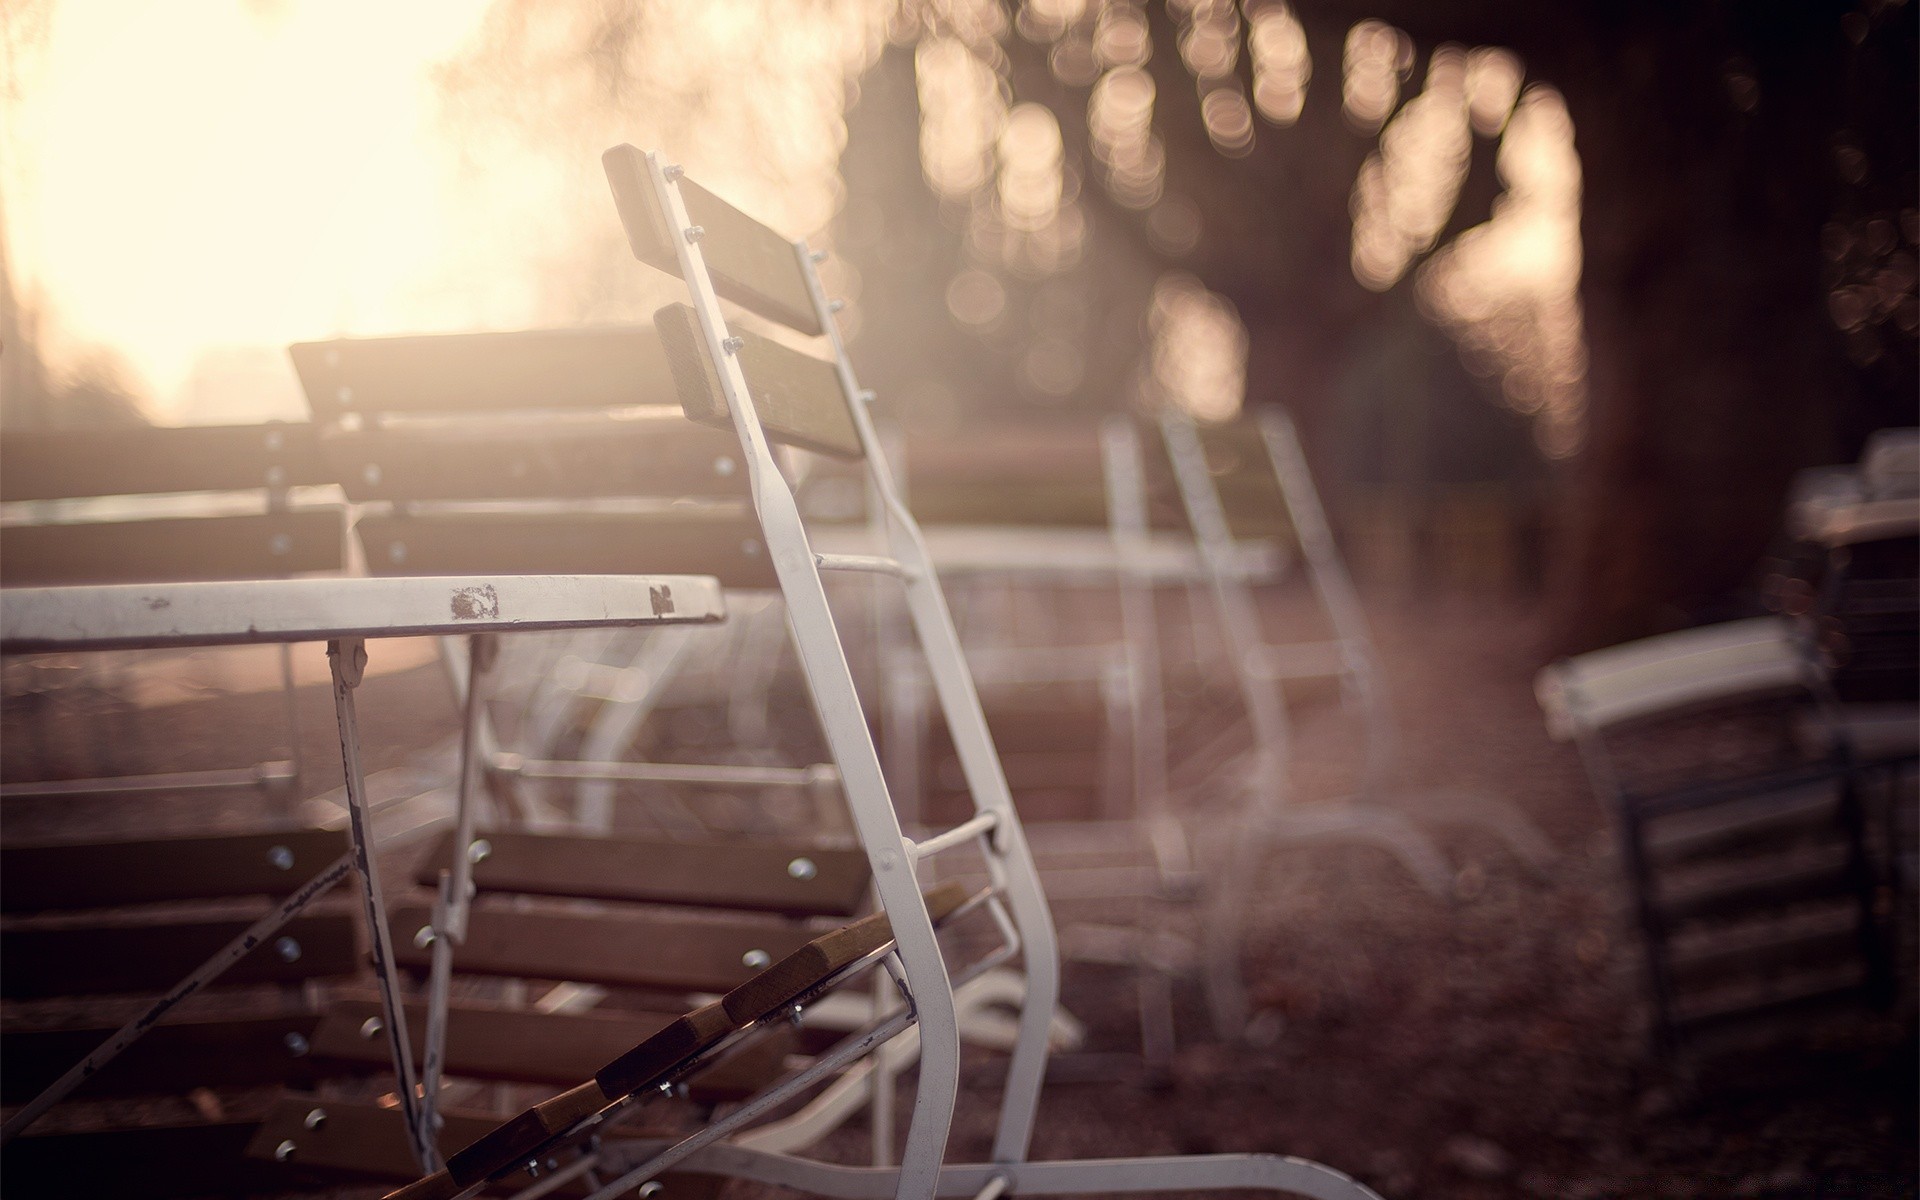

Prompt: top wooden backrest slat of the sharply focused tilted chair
[{"left": 601, "top": 146, "right": 826, "bottom": 334}]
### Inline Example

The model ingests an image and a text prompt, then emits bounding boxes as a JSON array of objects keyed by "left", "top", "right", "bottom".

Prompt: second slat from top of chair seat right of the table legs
[{"left": 392, "top": 904, "right": 810, "bottom": 993}]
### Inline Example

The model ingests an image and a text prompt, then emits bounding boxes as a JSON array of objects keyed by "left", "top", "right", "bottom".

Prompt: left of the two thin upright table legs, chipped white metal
[{"left": 326, "top": 637, "right": 440, "bottom": 1173}]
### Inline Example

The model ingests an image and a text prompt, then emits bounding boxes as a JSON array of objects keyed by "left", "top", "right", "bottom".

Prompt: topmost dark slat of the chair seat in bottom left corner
[{"left": 0, "top": 829, "right": 348, "bottom": 912}]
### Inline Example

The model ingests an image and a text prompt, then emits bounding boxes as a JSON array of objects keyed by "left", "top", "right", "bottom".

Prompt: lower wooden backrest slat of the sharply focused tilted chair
[{"left": 653, "top": 303, "right": 866, "bottom": 459}]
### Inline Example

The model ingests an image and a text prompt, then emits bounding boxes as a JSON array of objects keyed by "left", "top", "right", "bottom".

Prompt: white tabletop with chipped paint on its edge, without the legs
[{"left": 0, "top": 574, "right": 726, "bottom": 653}]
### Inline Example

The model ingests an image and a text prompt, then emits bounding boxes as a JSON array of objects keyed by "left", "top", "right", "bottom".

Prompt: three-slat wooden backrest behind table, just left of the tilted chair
[{"left": 290, "top": 328, "right": 772, "bottom": 588}]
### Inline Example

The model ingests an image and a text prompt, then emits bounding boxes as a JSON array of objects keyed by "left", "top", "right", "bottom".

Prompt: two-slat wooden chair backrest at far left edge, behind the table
[{"left": 0, "top": 424, "right": 344, "bottom": 586}]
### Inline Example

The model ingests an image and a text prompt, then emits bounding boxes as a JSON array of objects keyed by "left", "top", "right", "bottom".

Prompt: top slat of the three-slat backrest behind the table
[{"left": 288, "top": 326, "right": 672, "bottom": 422}]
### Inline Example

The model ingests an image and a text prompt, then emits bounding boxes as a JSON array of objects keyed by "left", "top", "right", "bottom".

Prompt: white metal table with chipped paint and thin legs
[{"left": 0, "top": 576, "right": 726, "bottom": 1158}]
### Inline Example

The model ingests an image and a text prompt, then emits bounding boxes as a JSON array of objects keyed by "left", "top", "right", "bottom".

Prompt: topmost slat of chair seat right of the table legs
[{"left": 417, "top": 829, "right": 868, "bottom": 916}]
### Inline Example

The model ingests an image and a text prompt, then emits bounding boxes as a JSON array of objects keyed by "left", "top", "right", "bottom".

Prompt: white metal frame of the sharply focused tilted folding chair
[{"left": 595, "top": 146, "right": 1371, "bottom": 1198}]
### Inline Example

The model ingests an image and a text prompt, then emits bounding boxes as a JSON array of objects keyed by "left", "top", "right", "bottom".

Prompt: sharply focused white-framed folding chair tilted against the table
[{"left": 568, "top": 146, "right": 1369, "bottom": 1196}]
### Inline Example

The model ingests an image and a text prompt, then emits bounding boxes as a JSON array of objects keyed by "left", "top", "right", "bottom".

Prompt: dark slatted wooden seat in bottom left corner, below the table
[{"left": 0, "top": 829, "right": 365, "bottom": 1196}]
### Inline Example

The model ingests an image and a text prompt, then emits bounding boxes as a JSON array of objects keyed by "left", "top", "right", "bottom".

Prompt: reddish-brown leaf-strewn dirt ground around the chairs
[{"left": 0, "top": 583, "right": 1920, "bottom": 1198}]
